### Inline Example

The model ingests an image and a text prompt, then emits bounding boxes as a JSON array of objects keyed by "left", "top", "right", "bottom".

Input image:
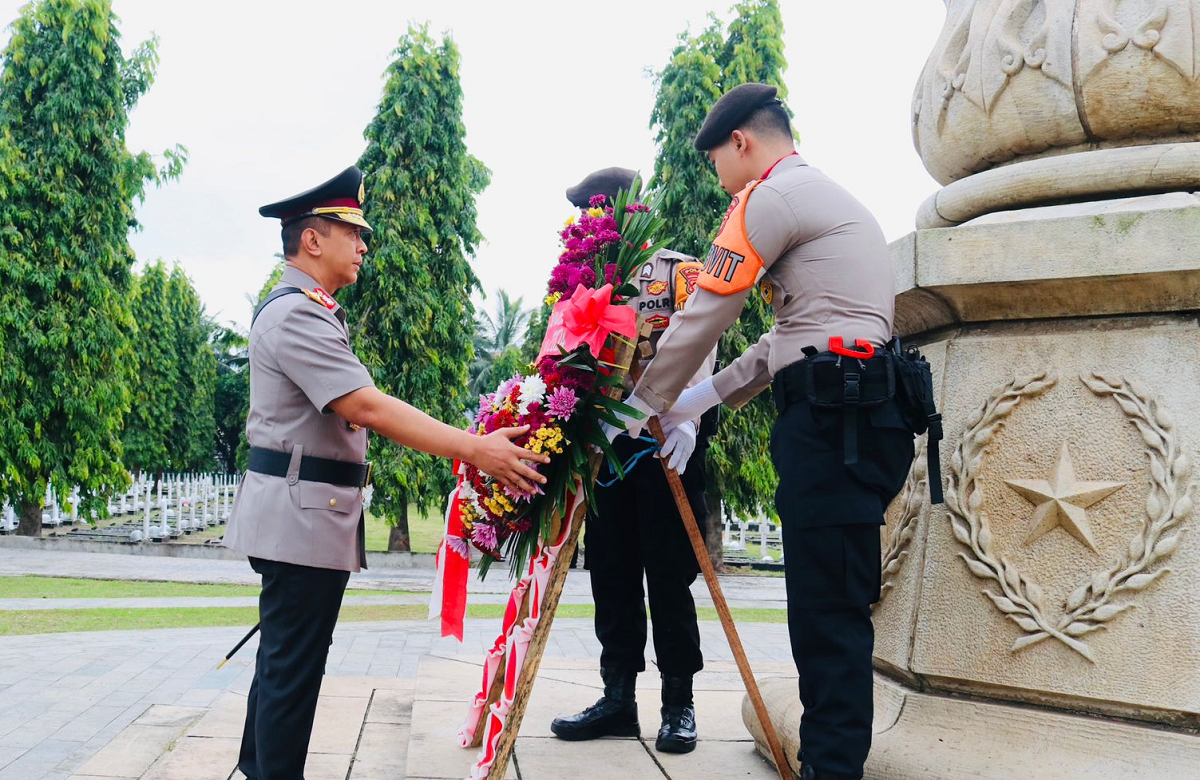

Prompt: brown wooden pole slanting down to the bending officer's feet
[{"left": 630, "top": 352, "right": 793, "bottom": 780}]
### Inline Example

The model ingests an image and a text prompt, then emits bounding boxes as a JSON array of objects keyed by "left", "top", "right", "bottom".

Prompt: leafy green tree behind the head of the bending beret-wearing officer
[{"left": 650, "top": 0, "right": 787, "bottom": 562}]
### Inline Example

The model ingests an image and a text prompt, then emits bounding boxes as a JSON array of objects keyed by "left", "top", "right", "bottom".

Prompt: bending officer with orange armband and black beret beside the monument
[{"left": 609, "top": 84, "right": 913, "bottom": 780}]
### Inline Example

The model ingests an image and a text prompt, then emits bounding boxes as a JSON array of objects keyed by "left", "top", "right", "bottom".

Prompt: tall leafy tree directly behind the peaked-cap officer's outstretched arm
[{"left": 340, "top": 25, "right": 491, "bottom": 550}]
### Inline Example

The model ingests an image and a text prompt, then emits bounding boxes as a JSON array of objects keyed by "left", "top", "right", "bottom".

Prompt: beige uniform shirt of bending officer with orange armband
[{"left": 636, "top": 156, "right": 895, "bottom": 413}]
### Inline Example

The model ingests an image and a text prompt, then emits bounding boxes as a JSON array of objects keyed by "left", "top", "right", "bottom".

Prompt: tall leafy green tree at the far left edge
[{"left": 0, "top": 0, "right": 186, "bottom": 535}]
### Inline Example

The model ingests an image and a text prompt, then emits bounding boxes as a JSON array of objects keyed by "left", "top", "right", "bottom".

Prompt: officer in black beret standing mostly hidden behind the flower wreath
[{"left": 551, "top": 168, "right": 716, "bottom": 752}]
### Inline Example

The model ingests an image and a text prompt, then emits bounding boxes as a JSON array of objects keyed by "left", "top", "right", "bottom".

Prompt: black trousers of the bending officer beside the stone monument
[{"left": 772, "top": 402, "right": 913, "bottom": 778}]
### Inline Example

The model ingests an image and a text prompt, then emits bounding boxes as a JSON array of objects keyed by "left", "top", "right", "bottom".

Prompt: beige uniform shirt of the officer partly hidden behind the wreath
[{"left": 626, "top": 250, "right": 716, "bottom": 425}]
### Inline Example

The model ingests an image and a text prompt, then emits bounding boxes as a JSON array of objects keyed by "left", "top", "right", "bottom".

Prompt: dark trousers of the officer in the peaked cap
[{"left": 238, "top": 558, "right": 350, "bottom": 780}]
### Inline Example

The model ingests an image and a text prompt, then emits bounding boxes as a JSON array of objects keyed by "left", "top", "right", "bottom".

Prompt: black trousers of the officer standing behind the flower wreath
[{"left": 586, "top": 436, "right": 707, "bottom": 677}]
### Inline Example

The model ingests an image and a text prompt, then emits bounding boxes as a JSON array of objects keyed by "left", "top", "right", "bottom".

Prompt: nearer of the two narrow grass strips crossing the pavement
[{"left": 0, "top": 604, "right": 787, "bottom": 633}]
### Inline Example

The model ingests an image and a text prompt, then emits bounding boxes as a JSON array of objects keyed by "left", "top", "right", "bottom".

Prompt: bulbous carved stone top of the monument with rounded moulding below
[{"left": 912, "top": 0, "right": 1200, "bottom": 227}]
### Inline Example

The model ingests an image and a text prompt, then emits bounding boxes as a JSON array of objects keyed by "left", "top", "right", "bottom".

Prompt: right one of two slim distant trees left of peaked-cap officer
[{"left": 167, "top": 268, "right": 217, "bottom": 472}]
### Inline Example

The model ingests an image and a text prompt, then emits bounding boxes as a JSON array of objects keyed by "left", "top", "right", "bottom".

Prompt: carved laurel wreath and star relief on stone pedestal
[{"left": 946, "top": 372, "right": 1193, "bottom": 662}]
